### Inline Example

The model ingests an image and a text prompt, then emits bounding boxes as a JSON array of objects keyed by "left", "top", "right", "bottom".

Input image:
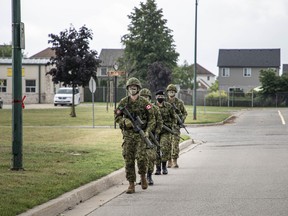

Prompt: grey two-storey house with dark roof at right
[{"left": 217, "top": 49, "right": 280, "bottom": 92}]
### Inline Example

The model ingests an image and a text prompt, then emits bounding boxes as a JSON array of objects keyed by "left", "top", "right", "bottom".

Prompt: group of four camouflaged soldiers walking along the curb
[{"left": 115, "top": 77, "right": 187, "bottom": 194}]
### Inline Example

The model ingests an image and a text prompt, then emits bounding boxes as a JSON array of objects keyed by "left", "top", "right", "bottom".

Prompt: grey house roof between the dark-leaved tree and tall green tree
[{"left": 99, "top": 49, "right": 124, "bottom": 67}]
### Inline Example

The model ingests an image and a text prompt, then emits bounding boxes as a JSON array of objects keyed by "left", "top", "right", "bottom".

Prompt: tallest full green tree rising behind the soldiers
[{"left": 121, "top": 0, "right": 179, "bottom": 84}]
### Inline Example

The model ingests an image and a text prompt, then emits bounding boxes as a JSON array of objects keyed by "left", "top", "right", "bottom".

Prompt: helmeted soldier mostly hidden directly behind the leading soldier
[{"left": 140, "top": 88, "right": 163, "bottom": 185}]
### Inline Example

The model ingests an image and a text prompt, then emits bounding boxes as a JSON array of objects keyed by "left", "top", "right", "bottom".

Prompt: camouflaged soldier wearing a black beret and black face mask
[{"left": 155, "top": 90, "right": 176, "bottom": 175}]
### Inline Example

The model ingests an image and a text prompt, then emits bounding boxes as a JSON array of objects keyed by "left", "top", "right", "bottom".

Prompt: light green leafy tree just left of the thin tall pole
[{"left": 172, "top": 61, "right": 194, "bottom": 89}]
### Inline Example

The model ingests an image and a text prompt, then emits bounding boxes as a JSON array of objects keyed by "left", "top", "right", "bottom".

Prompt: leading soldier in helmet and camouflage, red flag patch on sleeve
[{"left": 115, "top": 77, "right": 155, "bottom": 194}]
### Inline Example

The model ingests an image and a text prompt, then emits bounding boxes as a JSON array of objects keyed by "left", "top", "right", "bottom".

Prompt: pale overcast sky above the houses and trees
[{"left": 0, "top": 0, "right": 288, "bottom": 75}]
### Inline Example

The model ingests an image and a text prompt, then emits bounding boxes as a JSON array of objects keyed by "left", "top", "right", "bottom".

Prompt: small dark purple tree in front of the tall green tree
[{"left": 147, "top": 62, "right": 171, "bottom": 92}]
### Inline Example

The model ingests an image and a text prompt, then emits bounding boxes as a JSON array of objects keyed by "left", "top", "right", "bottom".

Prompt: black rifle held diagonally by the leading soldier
[{"left": 119, "top": 106, "right": 154, "bottom": 148}]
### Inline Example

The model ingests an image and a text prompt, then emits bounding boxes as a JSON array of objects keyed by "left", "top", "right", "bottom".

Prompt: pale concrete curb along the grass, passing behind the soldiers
[{"left": 18, "top": 139, "right": 196, "bottom": 216}]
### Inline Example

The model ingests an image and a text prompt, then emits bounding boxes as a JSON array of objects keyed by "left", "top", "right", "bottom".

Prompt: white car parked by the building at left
[{"left": 54, "top": 87, "right": 80, "bottom": 106}]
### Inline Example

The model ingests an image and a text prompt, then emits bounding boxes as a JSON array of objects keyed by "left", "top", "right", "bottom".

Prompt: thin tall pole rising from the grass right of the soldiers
[{"left": 193, "top": 0, "right": 199, "bottom": 120}]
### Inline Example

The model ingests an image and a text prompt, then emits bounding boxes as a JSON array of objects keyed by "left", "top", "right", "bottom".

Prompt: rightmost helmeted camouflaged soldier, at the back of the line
[{"left": 166, "top": 84, "right": 188, "bottom": 168}]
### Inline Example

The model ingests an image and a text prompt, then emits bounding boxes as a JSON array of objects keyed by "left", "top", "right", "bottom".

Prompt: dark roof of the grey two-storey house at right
[{"left": 217, "top": 49, "right": 280, "bottom": 68}]
